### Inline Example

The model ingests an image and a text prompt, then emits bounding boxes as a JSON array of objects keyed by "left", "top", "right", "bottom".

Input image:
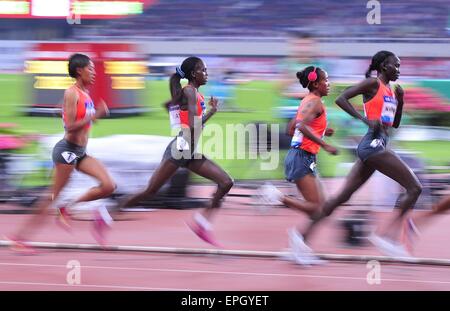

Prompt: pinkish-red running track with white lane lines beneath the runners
[{"left": 0, "top": 199, "right": 450, "bottom": 291}]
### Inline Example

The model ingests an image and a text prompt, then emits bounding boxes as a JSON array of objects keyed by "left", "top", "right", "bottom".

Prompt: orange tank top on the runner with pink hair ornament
[{"left": 291, "top": 93, "right": 327, "bottom": 154}]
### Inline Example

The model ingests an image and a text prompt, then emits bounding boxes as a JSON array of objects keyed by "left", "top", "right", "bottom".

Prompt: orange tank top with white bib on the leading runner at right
[{"left": 364, "top": 79, "right": 397, "bottom": 126}]
